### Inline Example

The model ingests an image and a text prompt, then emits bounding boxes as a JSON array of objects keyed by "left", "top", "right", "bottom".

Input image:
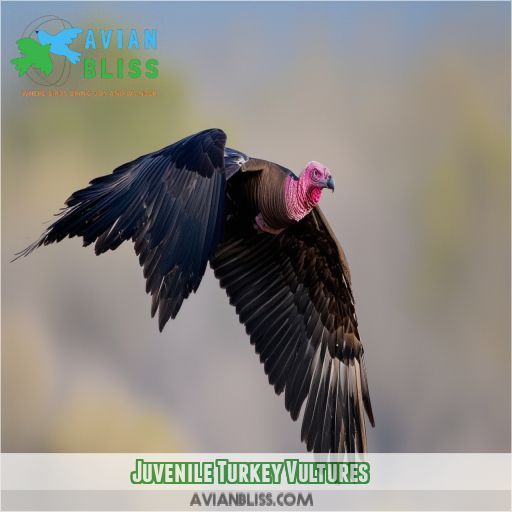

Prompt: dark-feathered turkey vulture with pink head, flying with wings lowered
[{"left": 18, "top": 129, "right": 374, "bottom": 452}]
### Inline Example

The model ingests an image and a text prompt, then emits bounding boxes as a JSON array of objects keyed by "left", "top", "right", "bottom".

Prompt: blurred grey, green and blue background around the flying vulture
[{"left": 2, "top": 2, "right": 511, "bottom": 452}]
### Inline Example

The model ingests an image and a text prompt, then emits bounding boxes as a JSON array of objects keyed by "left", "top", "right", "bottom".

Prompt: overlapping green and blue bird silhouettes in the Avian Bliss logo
[{"left": 11, "top": 28, "right": 82, "bottom": 76}]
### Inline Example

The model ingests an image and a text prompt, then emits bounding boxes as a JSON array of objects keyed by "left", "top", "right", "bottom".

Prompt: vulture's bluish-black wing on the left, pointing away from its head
[{"left": 19, "top": 129, "right": 226, "bottom": 330}]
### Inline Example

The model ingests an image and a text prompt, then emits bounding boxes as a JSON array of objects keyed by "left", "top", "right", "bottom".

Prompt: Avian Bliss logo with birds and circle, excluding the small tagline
[{"left": 10, "top": 15, "right": 158, "bottom": 86}]
